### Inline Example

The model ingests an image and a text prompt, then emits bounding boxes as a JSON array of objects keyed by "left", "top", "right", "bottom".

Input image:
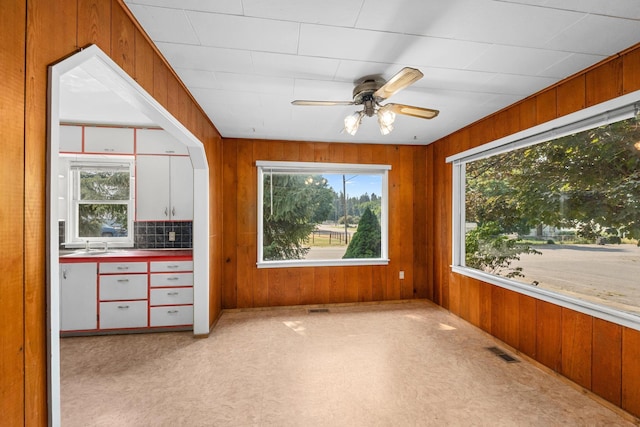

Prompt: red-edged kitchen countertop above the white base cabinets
[{"left": 60, "top": 249, "right": 193, "bottom": 262}]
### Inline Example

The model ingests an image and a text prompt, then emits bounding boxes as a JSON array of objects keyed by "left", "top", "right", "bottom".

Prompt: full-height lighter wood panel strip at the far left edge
[{"left": 0, "top": 1, "right": 26, "bottom": 425}]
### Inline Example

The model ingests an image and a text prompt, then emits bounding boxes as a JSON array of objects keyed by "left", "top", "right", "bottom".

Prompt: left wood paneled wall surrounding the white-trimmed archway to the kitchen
[{"left": 0, "top": 0, "right": 222, "bottom": 426}]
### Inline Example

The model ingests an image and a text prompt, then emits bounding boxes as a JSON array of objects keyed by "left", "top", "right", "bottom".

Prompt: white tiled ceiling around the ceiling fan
[{"left": 125, "top": 0, "right": 640, "bottom": 144}]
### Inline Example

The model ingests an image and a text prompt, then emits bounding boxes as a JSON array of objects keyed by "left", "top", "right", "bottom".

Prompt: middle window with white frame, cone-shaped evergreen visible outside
[{"left": 256, "top": 161, "right": 391, "bottom": 267}]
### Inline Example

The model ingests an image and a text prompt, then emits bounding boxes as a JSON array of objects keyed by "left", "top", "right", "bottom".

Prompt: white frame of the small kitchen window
[{"left": 64, "top": 155, "right": 135, "bottom": 248}]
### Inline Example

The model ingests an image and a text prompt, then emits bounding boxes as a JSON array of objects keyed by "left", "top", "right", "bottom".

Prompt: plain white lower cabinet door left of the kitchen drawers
[{"left": 60, "top": 262, "right": 98, "bottom": 331}]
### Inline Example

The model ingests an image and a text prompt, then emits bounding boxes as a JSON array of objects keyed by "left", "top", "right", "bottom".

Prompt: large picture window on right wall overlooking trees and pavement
[{"left": 448, "top": 94, "right": 640, "bottom": 327}]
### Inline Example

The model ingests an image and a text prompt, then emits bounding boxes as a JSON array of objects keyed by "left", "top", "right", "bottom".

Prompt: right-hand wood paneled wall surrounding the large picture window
[{"left": 427, "top": 45, "right": 640, "bottom": 417}]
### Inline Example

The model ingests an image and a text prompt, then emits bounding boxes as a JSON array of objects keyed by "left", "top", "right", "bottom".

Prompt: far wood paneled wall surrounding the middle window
[{"left": 222, "top": 139, "right": 430, "bottom": 308}]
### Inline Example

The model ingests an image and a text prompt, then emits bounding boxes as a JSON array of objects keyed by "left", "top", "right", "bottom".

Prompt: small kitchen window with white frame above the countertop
[{"left": 66, "top": 158, "right": 134, "bottom": 246}]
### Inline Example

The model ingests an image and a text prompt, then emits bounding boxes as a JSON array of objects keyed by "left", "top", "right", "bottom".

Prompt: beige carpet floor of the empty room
[{"left": 61, "top": 301, "right": 633, "bottom": 427}]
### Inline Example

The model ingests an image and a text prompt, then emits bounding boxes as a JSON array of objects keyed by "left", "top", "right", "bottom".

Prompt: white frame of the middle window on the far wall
[{"left": 256, "top": 160, "right": 391, "bottom": 268}]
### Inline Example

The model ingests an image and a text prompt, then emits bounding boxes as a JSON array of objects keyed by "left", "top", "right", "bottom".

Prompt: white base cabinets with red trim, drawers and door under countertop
[{"left": 60, "top": 256, "right": 193, "bottom": 335}]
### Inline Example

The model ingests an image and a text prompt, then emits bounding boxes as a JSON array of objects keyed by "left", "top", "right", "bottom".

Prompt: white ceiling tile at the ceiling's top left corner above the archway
[{"left": 129, "top": 4, "right": 199, "bottom": 44}]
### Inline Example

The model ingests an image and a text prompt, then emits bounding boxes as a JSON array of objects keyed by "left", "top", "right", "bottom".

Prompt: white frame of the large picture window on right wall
[{"left": 446, "top": 90, "right": 640, "bottom": 330}]
